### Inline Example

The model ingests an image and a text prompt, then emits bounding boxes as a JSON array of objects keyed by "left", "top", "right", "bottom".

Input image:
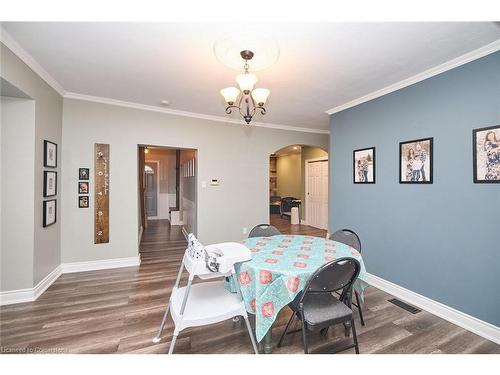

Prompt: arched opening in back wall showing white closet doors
[{"left": 269, "top": 144, "right": 328, "bottom": 233}]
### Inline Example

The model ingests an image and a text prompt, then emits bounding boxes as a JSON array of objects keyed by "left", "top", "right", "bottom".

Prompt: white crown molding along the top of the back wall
[{"left": 64, "top": 92, "right": 330, "bottom": 134}]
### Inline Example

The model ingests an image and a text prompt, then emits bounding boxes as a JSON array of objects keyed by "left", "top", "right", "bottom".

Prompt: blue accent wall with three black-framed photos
[{"left": 329, "top": 52, "right": 500, "bottom": 326}]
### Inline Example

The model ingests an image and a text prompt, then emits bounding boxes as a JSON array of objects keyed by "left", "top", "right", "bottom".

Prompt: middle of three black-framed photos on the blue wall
[{"left": 399, "top": 138, "right": 434, "bottom": 184}]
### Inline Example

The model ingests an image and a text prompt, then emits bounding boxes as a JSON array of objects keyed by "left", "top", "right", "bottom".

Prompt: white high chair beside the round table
[{"left": 153, "top": 242, "right": 258, "bottom": 354}]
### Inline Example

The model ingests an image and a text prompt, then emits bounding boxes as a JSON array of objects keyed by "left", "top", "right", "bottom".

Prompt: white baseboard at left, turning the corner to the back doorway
[{"left": 0, "top": 255, "right": 141, "bottom": 306}]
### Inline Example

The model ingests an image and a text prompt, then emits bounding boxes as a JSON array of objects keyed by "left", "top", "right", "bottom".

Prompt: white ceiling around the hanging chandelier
[{"left": 2, "top": 22, "right": 500, "bottom": 130}]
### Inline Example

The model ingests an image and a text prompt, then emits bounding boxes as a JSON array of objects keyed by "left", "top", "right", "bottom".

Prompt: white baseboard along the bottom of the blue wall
[{"left": 367, "top": 273, "right": 500, "bottom": 344}]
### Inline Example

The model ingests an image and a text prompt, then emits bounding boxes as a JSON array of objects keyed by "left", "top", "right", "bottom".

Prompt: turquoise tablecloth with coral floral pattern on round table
[{"left": 227, "top": 235, "right": 368, "bottom": 342}]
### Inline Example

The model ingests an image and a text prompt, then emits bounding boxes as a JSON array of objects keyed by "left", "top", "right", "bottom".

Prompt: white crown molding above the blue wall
[{"left": 326, "top": 39, "right": 500, "bottom": 115}]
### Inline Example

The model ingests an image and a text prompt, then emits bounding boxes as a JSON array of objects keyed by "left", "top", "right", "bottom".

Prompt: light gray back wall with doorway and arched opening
[{"left": 61, "top": 99, "right": 328, "bottom": 262}]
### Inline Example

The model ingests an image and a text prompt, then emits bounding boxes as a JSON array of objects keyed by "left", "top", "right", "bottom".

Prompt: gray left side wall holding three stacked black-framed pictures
[{"left": 0, "top": 44, "right": 63, "bottom": 285}]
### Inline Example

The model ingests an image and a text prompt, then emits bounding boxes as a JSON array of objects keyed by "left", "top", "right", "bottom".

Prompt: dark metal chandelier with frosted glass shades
[{"left": 220, "top": 50, "right": 270, "bottom": 124}]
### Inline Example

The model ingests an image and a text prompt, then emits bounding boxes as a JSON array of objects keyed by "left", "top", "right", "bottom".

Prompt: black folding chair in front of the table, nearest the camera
[{"left": 278, "top": 258, "right": 361, "bottom": 354}]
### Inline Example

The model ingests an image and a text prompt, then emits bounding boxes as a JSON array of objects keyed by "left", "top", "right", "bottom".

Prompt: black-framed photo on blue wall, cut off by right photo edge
[{"left": 472, "top": 125, "right": 500, "bottom": 183}]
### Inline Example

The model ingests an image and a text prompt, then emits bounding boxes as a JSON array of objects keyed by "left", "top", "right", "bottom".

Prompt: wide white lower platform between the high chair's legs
[{"left": 170, "top": 280, "right": 246, "bottom": 330}]
